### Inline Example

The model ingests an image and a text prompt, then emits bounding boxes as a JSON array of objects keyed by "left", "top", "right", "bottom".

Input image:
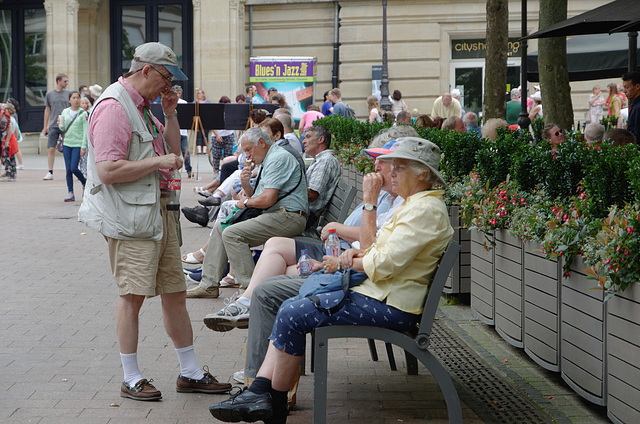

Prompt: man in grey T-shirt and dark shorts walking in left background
[{"left": 42, "top": 74, "right": 71, "bottom": 181}]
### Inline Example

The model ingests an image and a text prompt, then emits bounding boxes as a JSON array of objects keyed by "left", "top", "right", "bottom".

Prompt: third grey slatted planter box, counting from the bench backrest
[{"left": 494, "top": 230, "right": 524, "bottom": 348}]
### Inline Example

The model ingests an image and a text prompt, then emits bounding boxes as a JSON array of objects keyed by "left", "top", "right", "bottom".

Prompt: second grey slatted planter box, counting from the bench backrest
[{"left": 470, "top": 231, "right": 495, "bottom": 325}]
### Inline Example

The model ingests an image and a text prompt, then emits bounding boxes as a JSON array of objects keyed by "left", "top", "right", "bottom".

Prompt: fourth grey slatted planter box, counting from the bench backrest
[{"left": 524, "top": 242, "right": 562, "bottom": 372}]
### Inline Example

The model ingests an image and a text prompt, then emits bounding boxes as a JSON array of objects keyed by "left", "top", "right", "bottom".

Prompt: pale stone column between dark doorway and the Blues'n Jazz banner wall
[{"left": 193, "top": 0, "right": 245, "bottom": 102}]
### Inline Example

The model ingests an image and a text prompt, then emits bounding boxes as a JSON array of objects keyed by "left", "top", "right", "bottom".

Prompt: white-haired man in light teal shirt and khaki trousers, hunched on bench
[{"left": 189, "top": 127, "right": 309, "bottom": 298}]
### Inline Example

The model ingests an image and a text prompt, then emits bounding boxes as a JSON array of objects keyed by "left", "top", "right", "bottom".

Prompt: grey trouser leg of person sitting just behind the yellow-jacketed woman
[{"left": 244, "top": 275, "right": 304, "bottom": 378}]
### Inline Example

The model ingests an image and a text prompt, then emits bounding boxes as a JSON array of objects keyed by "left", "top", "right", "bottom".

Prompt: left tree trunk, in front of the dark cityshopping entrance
[{"left": 482, "top": 0, "right": 509, "bottom": 121}]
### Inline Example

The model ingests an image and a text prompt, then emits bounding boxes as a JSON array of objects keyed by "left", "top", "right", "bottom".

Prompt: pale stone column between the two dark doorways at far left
[{"left": 44, "top": 0, "right": 79, "bottom": 89}]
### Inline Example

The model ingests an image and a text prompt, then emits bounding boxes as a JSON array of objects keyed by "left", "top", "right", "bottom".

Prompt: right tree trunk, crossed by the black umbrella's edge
[{"left": 538, "top": 0, "right": 573, "bottom": 130}]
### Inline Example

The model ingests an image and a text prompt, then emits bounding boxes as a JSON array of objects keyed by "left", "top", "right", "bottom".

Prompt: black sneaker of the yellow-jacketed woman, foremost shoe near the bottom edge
[{"left": 209, "top": 386, "right": 273, "bottom": 423}]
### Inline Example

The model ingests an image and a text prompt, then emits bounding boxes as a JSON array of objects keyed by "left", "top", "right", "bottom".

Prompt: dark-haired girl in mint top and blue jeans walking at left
[{"left": 58, "top": 91, "right": 88, "bottom": 202}]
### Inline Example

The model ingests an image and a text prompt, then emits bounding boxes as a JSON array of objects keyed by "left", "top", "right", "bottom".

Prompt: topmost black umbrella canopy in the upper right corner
[{"left": 523, "top": 0, "right": 640, "bottom": 39}]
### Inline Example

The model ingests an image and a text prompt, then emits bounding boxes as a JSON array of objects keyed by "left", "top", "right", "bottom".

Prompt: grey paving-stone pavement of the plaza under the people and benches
[{"left": 0, "top": 155, "right": 607, "bottom": 424}]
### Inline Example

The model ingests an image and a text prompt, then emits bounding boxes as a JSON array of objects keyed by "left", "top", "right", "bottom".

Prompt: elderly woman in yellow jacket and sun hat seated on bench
[{"left": 209, "top": 137, "right": 453, "bottom": 424}]
